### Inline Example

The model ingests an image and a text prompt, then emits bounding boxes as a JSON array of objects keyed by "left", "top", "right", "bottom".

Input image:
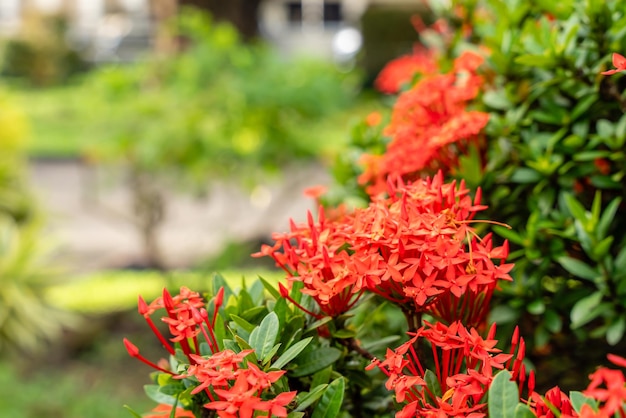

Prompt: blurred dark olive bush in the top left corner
[{"left": 0, "top": 10, "right": 86, "bottom": 87}]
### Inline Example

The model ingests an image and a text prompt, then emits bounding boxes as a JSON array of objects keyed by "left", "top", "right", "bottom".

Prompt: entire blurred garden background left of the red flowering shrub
[{"left": 0, "top": 0, "right": 424, "bottom": 418}]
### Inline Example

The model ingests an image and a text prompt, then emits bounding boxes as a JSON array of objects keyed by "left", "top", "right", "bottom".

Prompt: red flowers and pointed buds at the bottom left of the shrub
[{"left": 124, "top": 287, "right": 296, "bottom": 418}]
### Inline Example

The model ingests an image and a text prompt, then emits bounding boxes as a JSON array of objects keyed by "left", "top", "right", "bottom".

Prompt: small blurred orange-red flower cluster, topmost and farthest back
[{"left": 374, "top": 48, "right": 438, "bottom": 94}]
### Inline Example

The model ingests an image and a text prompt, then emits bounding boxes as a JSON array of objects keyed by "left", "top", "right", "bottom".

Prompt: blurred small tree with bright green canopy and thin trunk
[{"left": 84, "top": 11, "right": 357, "bottom": 267}]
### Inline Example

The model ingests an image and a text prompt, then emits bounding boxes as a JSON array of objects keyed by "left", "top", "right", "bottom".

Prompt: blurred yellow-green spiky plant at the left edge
[{"left": 0, "top": 95, "right": 75, "bottom": 354}]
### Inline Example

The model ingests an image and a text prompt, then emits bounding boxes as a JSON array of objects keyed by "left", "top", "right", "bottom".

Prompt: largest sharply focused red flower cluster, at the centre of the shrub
[{"left": 255, "top": 173, "right": 512, "bottom": 326}]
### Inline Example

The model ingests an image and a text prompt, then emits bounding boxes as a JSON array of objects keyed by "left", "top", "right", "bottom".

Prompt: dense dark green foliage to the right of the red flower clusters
[{"left": 330, "top": 0, "right": 626, "bottom": 388}]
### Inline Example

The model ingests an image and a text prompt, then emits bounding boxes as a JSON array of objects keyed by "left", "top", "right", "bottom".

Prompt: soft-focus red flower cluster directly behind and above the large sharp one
[{"left": 359, "top": 52, "right": 489, "bottom": 195}]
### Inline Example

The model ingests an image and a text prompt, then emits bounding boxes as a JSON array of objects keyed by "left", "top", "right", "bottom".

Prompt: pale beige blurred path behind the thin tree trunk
[{"left": 29, "top": 160, "right": 329, "bottom": 273}]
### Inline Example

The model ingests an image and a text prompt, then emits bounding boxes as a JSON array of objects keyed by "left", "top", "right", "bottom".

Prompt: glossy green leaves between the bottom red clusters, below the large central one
[{"left": 125, "top": 275, "right": 406, "bottom": 417}]
